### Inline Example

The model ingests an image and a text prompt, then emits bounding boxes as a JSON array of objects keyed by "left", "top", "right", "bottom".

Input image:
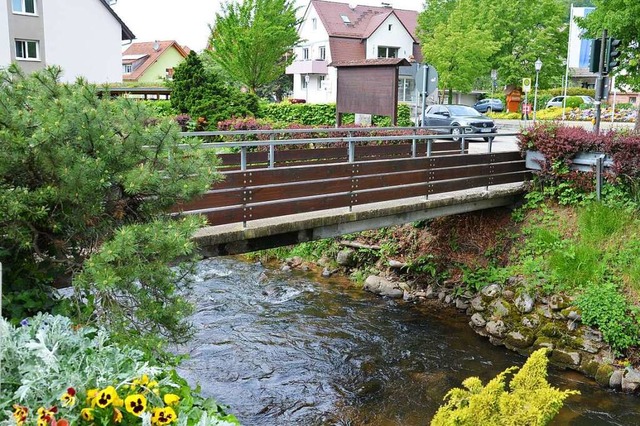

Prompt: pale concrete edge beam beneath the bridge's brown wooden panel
[{"left": 195, "top": 184, "right": 525, "bottom": 257}]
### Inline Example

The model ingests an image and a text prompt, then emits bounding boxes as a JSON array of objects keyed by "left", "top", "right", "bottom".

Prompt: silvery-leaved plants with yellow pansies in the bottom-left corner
[{"left": 0, "top": 314, "right": 239, "bottom": 426}]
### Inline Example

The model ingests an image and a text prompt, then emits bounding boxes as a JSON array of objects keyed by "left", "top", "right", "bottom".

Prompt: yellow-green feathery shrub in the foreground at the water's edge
[{"left": 431, "top": 349, "right": 580, "bottom": 426}]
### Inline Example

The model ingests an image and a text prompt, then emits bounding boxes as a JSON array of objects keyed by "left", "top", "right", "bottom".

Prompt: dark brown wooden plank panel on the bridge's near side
[{"left": 176, "top": 151, "right": 531, "bottom": 224}]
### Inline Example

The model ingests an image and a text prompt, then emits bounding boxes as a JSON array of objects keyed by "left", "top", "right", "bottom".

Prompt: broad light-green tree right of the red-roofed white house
[{"left": 418, "top": 0, "right": 567, "bottom": 94}]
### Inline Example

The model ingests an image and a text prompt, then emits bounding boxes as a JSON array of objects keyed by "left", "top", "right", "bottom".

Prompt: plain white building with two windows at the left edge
[{"left": 0, "top": 0, "right": 135, "bottom": 83}]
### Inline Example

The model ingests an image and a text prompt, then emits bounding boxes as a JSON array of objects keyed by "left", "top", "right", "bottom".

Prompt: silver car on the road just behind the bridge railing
[{"left": 424, "top": 105, "right": 498, "bottom": 141}]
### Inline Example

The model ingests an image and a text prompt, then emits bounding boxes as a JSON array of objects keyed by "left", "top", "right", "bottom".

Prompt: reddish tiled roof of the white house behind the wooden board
[{"left": 310, "top": 0, "right": 418, "bottom": 41}]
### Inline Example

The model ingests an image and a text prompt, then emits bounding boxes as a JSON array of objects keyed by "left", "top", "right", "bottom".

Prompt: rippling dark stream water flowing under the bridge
[{"left": 174, "top": 258, "right": 640, "bottom": 426}]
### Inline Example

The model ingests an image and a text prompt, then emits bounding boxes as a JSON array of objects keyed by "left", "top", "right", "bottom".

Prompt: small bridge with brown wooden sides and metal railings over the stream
[{"left": 175, "top": 127, "right": 531, "bottom": 256}]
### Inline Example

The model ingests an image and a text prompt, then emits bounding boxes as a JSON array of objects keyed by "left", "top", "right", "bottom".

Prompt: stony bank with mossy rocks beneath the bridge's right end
[{"left": 256, "top": 204, "right": 640, "bottom": 393}]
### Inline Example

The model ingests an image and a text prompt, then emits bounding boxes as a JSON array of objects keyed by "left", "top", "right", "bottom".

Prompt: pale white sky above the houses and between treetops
[{"left": 112, "top": 0, "right": 424, "bottom": 51}]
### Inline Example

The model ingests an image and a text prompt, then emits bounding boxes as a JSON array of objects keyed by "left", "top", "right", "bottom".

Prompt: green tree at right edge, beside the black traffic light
[{"left": 578, "top": 0, "right": 640, "bottom": 130}]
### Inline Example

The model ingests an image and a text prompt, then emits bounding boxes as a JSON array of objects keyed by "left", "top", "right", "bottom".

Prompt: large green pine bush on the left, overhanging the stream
[{"left": 0, "top": 66, "right": 216, "bottom": 350}]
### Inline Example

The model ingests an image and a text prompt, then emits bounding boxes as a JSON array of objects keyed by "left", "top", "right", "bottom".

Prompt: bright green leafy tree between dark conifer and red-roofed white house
[{"left": 209, "top": 0, "right": 300, "bottom": 93}]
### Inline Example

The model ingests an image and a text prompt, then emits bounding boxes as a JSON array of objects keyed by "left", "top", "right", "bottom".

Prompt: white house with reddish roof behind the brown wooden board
[{"left": 286, "top": 0, "right": 422, "bottom": 103}]
